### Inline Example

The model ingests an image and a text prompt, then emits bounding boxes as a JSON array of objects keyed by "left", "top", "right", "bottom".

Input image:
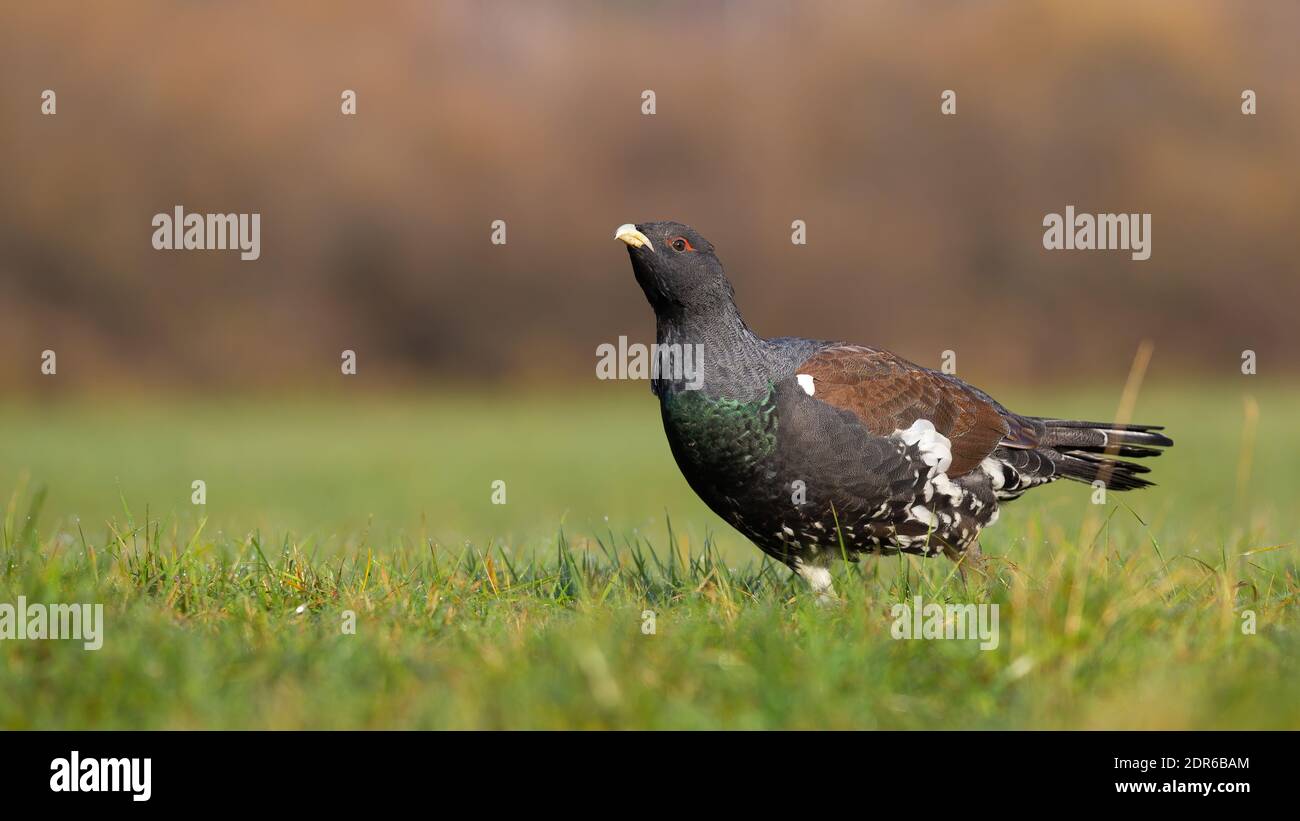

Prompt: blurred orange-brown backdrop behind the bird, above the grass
[{"left": 0, "top": 0, "right": 1300, "bottom": 395}]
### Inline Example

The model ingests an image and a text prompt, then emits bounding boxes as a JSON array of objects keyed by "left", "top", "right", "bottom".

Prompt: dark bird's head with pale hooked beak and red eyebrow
[{"left": 614, "top": 222, "right": 735, "bottom": 317}]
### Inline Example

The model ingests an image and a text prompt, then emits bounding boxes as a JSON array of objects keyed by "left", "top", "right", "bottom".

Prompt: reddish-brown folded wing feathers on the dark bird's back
[{"left": 796, "top": 346, "right": 1014, "bottom": 477}]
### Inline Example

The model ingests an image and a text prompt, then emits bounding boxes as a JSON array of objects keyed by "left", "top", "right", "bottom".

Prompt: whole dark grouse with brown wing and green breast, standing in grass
[{"left": 615, "top": 222, "right": 1173, "bottom": 596}]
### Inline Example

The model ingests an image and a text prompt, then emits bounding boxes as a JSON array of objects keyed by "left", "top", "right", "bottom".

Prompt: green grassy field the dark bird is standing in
[{"left": 0, "top": 386, "right": 1300, "bottom": 727}]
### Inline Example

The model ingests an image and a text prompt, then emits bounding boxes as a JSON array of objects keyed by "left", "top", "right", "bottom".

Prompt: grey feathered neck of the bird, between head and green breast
[{"left": 655, "top": 305, "right": 776, "bottom": 400}]
